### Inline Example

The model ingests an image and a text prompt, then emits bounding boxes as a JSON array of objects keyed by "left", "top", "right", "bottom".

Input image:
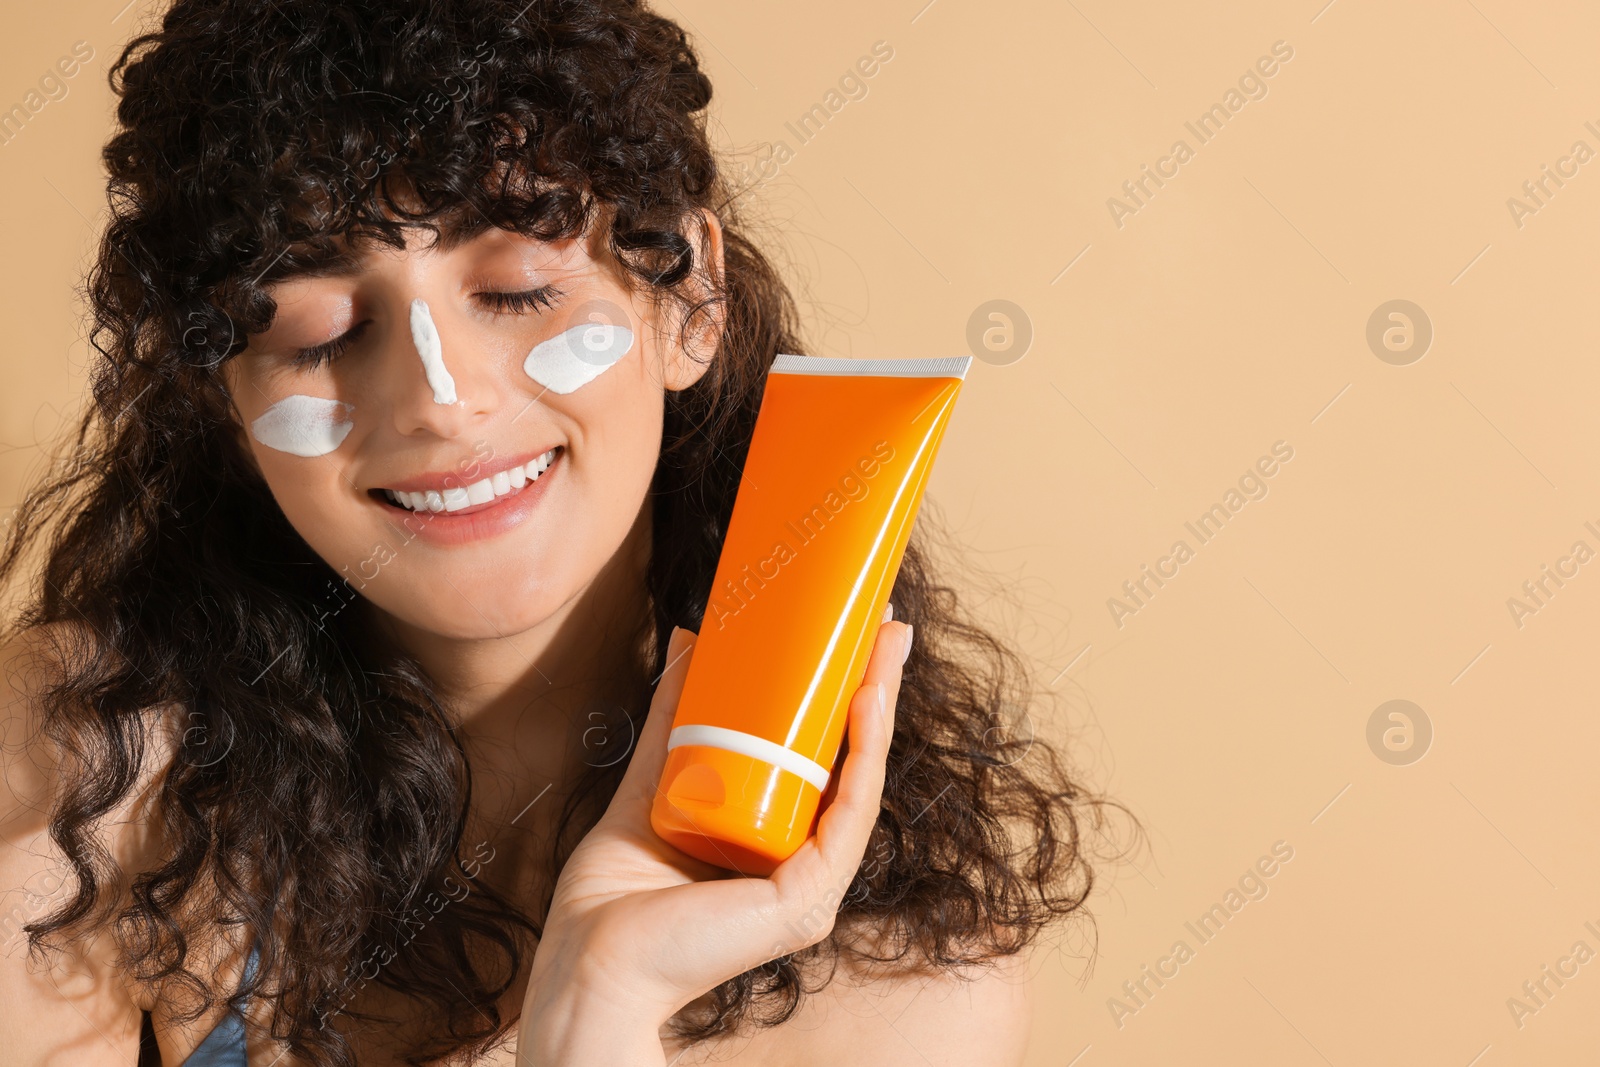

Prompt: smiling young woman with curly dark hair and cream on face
[{"left": 0, "top": 0, "right": 1102, "bottom": 1067}]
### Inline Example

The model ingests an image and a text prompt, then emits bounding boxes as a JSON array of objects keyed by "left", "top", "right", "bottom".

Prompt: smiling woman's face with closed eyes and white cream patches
[{"left": 224, "top": 212, "right": 722, "bottom": 638}]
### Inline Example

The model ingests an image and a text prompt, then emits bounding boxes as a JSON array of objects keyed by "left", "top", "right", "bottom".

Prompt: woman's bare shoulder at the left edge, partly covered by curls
[{"left": 0, "top": 625, "right": 178, "bottom": 1065}]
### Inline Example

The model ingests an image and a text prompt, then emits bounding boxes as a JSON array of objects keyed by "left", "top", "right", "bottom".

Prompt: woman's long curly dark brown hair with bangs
[{"left": 0, "top": 0, "right": 1115, "bottom": 1065}]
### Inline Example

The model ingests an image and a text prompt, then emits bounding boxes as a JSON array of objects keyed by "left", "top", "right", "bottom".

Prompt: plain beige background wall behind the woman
[{"left": 0, "top": 0, "right": 1600, "bottom": 1067}]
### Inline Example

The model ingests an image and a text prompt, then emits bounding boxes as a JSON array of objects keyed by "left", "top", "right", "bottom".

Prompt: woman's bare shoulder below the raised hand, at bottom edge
[{"left": 669, "top": 953, "right": 1032, "bottom": 1067}]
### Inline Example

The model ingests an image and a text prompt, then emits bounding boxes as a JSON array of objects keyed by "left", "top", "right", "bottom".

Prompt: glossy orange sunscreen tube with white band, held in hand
[{"left": 650, "top": 355, "right": 973, "bottom": 875}]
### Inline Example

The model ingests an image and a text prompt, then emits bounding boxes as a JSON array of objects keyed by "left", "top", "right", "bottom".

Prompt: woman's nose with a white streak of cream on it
[{"left": 384, "top": 299, "right": 499, "bottom": 438}]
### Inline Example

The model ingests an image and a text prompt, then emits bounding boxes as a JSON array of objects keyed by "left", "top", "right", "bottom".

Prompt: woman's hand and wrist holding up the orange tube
[{"left": 518, "top": 608, "right": 912, "bottom": 1067}]
